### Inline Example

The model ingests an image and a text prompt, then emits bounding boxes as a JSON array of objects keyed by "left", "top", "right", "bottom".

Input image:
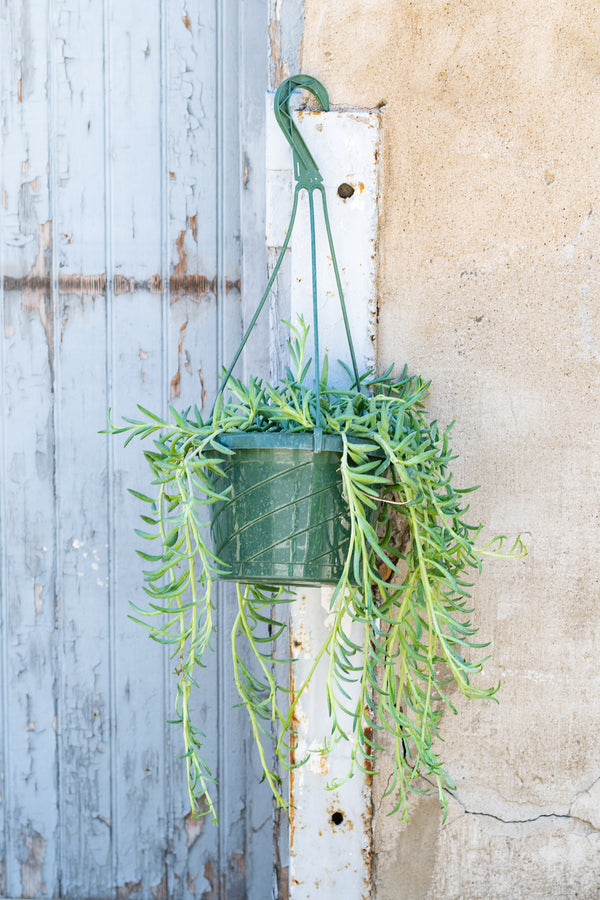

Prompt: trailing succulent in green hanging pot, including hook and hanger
[{"left": 109, "top": 76, "right": 525, "bottom": 819}]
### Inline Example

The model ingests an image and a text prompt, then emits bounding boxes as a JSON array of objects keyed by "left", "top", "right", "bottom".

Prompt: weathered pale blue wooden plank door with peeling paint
[{"left": 0, "top": 0, "right": 272, "bottom": 900}]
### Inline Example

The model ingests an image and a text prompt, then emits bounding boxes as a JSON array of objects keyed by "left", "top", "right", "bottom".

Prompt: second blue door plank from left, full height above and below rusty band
[{"left": 50, "top": 0, "right": 114, "bottom": 897}]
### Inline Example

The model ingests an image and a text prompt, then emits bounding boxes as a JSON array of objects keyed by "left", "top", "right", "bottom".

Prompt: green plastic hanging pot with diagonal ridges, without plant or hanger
[{"left": 211, "top": 434, "right": 372, "bottom": 585}]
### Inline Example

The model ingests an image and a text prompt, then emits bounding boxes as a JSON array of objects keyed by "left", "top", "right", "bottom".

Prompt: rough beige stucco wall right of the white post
[{"left": 302, "top": 0, "right": 600, "bottom": 900}]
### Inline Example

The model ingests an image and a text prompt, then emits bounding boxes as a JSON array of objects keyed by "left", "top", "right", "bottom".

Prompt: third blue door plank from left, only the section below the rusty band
[{"left": 109, "top": 292, "right": 168, "bottom": 898}]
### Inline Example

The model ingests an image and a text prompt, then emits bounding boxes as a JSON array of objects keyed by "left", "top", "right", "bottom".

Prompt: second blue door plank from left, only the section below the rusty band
[{"left": 56, "top": 295, "right": 114, "bottom": 898}]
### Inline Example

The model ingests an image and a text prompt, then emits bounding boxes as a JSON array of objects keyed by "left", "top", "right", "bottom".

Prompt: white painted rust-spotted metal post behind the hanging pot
[{"left": 267, "top": 95, "right": 379, "bottom": 900}]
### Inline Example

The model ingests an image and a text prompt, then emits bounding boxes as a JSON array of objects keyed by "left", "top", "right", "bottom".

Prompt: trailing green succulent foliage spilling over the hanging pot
[{"left": 109, "top": 319, "right": 526, "bottom": 820}]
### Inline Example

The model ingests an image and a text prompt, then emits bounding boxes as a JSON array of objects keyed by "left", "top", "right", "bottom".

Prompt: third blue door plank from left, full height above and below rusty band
[{"left": 105, "top": 2, "right": 172, "bottom": 900}]
